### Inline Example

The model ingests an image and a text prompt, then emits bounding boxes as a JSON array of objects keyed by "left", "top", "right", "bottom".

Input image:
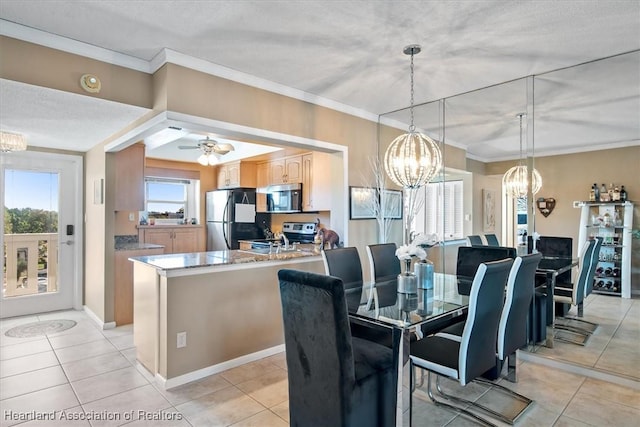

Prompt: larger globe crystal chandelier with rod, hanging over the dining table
[{"left": 384, "top": 44, "right": 442, "bottom": 189}]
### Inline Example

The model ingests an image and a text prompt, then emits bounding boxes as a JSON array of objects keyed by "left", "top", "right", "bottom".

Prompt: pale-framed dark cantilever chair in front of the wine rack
[{"left": 553, "top": 239, "right": 598, "bottom": 345}]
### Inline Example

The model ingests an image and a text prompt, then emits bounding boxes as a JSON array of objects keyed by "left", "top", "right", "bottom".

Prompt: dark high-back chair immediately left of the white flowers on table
[{"left": 366, "top": 243, "right": 401, "bottom": 308}]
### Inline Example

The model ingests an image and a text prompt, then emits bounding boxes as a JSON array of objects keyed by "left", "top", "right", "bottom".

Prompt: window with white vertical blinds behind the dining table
[{"left": 411, "top": 180, "right": 465, "bottom": 240}]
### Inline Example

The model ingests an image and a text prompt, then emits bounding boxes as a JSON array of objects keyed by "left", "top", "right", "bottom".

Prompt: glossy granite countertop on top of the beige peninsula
[{"left": 129, "top": 250, "right": 320, "bottom": 270}]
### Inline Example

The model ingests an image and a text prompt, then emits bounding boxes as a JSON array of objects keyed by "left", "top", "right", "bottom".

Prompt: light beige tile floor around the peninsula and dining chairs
[{"left": 0, "top": 298, "right": 640, "bottom": 427}]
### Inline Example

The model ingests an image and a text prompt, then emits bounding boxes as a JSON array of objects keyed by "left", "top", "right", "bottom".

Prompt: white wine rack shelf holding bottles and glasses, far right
[{"left": 574, "top": 201, "right": 633, "bottom": 298}]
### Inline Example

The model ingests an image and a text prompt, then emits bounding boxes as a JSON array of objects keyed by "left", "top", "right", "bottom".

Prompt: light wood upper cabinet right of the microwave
[{"left": 302, "top": 152, "right": 331, "bottom": 211}]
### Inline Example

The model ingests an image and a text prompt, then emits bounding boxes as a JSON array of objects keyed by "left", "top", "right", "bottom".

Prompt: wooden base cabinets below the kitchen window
[{"left": 138, "top": 225, "right": 204, "bottom": 254}]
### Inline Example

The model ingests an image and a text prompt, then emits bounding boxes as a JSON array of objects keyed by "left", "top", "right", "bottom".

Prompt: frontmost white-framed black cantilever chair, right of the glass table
[{"left": 409, "top": 259, "right": 513, "bottom": 425}]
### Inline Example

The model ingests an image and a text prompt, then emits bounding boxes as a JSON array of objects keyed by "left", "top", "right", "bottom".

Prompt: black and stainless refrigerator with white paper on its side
[{"left": 205, "top": 188, "right": 271, "bottom": 251}]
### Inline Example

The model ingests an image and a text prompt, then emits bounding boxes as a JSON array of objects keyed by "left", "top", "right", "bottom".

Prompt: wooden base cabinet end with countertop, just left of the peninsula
[{"left": 113, "top": 248, "right": 164, "bottom": 326}]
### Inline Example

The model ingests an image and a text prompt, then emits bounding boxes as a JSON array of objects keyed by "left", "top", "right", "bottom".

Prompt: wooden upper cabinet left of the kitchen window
[{"left": 115, "top": 142, "right": 145, "bottom": 211}]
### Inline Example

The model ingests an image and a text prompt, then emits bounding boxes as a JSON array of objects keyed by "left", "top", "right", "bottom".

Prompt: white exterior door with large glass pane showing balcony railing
[{"left": 0, "top": 152, "right": 83, "bottom": 318}]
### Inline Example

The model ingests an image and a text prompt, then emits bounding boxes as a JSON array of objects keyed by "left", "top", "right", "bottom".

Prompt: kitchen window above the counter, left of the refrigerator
[{"left": 145, "top": 177, "right": 200, "bottom": 223}]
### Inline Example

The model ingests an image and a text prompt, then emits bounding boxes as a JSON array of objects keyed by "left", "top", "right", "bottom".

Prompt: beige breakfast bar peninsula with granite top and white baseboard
[{"left": 130, "top": 249, "right": 324, "bottom": 389}]
